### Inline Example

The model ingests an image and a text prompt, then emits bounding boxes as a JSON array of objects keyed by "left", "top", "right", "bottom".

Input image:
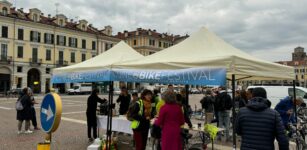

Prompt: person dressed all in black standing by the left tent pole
[{"left": 86, "top": 89, "right": 107, "bottom": 142}]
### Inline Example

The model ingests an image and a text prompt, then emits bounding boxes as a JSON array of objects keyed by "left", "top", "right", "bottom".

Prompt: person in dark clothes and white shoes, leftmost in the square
[{"left": 17, "top": 88, "right": 33, "bottom": 134}]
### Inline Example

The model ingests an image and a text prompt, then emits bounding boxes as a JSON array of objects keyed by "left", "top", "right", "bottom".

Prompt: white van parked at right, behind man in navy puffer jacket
[{"left": 247, "top": 85, "right": 307, "bottom": 108}]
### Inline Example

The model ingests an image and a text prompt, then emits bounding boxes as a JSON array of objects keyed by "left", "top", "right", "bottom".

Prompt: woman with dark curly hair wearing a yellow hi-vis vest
[{"left": 131, "top": 89, "right": 153, "bottom": 150}]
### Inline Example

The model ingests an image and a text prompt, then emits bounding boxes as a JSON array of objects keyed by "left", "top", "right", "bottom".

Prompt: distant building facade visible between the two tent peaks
[{"left": 116, "top": 28, "right": 188, "bottom": 56}]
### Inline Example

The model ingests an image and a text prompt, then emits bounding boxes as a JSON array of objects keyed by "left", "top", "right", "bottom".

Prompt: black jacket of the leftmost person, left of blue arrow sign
[{"left": 17, "top": 95, "right": 32, "bottom": 120}]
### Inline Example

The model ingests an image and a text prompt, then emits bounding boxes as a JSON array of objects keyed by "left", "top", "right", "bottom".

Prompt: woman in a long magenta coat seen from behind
[{"left": 155, "top": 91, "right": 184, "bottom": 150}]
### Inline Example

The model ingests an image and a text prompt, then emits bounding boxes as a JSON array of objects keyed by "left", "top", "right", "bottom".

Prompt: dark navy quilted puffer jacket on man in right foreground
[{"left": 235, "top": 97, "right": 289, "bottom": 150}]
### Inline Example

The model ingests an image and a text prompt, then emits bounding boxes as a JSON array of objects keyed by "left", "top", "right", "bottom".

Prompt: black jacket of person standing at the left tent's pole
[{"left": 86, "top": 94, "right": 106, "bottom": 117}]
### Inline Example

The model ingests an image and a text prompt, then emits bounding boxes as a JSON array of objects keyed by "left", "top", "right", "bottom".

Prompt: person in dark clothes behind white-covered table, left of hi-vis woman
[{"left": 116, "top": 87, "right": 131, "bottom": 115}]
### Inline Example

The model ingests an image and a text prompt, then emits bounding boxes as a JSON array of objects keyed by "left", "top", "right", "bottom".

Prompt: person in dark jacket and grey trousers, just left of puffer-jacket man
[{"left": 216, "top": 87, "right": 232, "bottom": 142}]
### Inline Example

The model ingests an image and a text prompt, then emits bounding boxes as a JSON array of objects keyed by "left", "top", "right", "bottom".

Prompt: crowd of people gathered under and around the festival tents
[{"left": 87, "top": 85, "right": 303, "bottom": 150}]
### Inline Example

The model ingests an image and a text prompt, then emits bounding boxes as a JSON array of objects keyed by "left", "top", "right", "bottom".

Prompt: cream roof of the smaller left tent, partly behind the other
[{"left": 53, "top": 41, "right": 144, "bottom": 74}]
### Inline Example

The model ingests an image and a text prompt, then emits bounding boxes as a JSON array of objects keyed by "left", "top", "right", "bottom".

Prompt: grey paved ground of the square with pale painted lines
[{"left": 0, "top": 94, "right": 238, "bottom": 150}]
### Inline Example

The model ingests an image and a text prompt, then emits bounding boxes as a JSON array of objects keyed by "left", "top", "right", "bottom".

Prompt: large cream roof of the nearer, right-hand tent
[{"left": 114, "top": 28, "right": 294, "bottom": 80}]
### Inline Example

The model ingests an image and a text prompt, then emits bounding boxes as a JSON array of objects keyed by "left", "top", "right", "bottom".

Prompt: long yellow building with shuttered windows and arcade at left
[{"left": 0, "top": 0, "right": 120, "bottom": 93}]
